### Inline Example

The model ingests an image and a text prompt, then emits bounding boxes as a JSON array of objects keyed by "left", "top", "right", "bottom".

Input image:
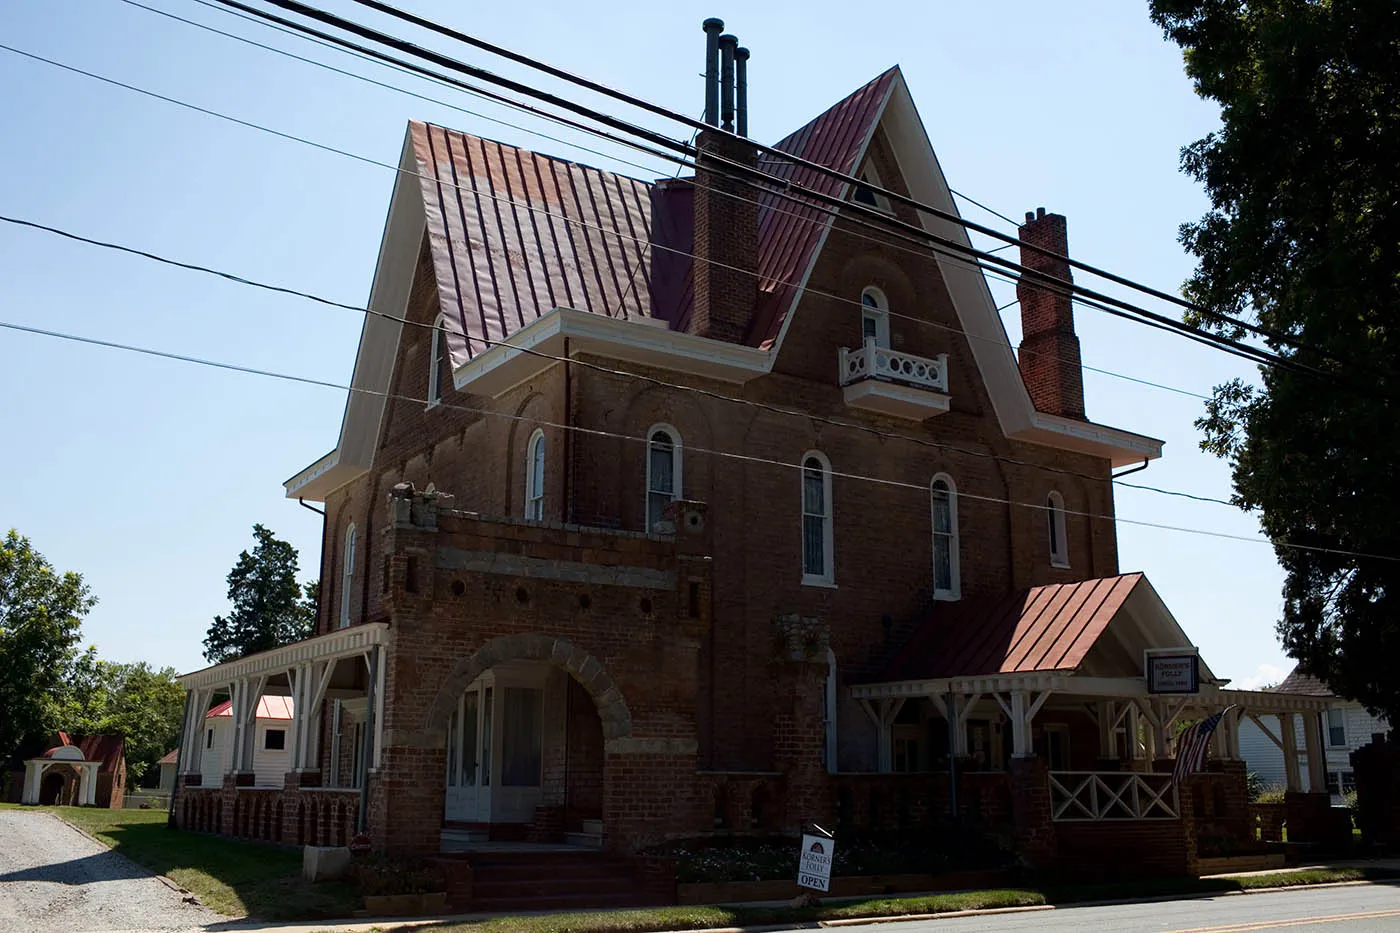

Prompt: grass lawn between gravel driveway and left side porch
[{"left": 4, "top": 804, "right": 358, "bottom": 920}]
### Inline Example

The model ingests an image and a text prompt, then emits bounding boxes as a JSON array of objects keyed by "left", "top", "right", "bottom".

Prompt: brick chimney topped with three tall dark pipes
[{"left": 690, "top": 18, "right": 759, "bottom": 343}]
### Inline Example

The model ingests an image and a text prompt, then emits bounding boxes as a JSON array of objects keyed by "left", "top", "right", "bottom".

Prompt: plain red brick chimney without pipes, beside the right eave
[{"left": 1016, "top": 207, "right": 1085, "bottom": 422}]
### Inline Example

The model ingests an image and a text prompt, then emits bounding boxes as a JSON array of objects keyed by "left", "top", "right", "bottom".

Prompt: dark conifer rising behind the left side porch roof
[{"left": 204, "top": 525, "right": 316, "bottom": 664}]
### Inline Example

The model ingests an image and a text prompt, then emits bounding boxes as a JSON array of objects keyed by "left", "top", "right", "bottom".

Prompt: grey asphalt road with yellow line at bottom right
[{"left": 879, "top": 884, "right": 1400, "bottom": 933}]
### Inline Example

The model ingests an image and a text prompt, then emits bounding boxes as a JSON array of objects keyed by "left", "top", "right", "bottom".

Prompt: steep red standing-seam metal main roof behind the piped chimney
[{"left": 409, "top": 69, "right": 897, "bottom": 366}]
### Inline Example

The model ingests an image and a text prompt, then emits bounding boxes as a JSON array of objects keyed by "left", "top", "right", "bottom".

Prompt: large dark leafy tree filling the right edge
[{"left": 1151, "top": 0, "right": 1400, "bottom": 723}]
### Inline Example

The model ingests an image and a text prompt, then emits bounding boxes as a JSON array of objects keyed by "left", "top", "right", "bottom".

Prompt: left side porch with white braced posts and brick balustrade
[{"left": 171, "top": 622, "right": 388, "bottom": 845}]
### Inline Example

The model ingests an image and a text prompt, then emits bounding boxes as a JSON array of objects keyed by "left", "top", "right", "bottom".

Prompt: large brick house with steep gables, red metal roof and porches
[{"left": 176, "top": 24, "right": 1344, "bottom": 870}]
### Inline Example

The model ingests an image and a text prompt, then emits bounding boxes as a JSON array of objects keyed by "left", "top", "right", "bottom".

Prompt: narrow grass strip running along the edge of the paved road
[{"left": 375, "top": 869, "right": 1397, "bottom": 933}]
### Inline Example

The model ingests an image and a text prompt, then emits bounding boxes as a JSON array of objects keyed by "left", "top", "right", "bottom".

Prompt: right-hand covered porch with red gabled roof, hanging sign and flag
[{"left": 851, "top": 574, "right": 1330, "bottom": 874}]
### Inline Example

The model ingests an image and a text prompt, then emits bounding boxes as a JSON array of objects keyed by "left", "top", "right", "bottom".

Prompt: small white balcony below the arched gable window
[{"left": 840, "top": 339, "right": 948, "bottom": 422}]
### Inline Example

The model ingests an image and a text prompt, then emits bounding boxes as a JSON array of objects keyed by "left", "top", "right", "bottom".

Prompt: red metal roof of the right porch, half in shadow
[{"left": 878, "top": 573, "right": 1142, "bottom": 681}]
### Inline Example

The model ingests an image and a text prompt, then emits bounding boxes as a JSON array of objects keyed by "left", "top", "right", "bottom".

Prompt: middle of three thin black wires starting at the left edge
[{"left": 0, "top": 208, "right": 1233, "bottom": 507}]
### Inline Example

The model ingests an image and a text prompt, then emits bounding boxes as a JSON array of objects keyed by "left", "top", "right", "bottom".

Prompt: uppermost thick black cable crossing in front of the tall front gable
[{"left": 320, "top": 0, "right": 1330, "bottom": 356}]
